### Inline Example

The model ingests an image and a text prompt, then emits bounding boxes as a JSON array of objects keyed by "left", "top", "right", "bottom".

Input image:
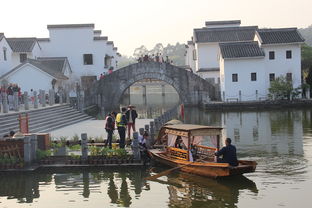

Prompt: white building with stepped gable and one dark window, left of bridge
[{"left": 38, "top": 24, "right": 119, "bottom": 78}]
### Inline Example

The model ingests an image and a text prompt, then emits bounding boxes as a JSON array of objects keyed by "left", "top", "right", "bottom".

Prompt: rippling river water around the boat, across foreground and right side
[{"left": 0, "top": 109, "right": 312, "bottom": 208}]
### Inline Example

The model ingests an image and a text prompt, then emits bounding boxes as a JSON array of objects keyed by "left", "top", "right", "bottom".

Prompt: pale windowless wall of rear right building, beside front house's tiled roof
[{"left": 196, "top": 43, "right": 219, "bottom": 70}]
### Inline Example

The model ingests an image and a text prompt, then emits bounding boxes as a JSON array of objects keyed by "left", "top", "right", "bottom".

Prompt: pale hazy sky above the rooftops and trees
[{"left": 0, "top": 0, "right": 312, "bottom": 56}]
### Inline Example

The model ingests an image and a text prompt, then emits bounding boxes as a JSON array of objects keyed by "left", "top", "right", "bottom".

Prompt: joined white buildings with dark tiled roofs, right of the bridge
[{"left": 186, "top": 20, "right": 304, "bottom": 101}]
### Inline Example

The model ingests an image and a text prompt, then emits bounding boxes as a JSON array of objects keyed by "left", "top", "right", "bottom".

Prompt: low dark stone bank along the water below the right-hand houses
[{"left": 201, "top": 99, "right": 312, "bottom": 111}]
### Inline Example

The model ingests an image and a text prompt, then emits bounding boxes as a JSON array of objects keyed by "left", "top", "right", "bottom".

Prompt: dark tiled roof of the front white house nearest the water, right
[{"left": 219, "top": 41, "right": 264, "bottom": 59}]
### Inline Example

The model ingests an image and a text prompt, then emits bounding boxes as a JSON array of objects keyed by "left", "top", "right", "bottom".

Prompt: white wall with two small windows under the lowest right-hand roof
[{"left": 220, "top": 58, "right": 268, "bottom": 101}]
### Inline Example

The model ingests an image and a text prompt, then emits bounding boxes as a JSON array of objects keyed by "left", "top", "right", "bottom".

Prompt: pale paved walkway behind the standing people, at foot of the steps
[{"left": 50, "top": 119, "right": 152, "bottom": 139}]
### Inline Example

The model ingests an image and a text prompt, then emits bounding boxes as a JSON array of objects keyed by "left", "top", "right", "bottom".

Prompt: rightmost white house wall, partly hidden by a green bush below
[{"left": 262, "top": 44, "right": 301, "bottom": 87}]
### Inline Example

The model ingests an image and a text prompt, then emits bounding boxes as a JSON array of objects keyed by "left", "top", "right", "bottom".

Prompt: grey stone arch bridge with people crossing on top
[{"left": 85, "top": 62, "right": 218, "bottom": 112}]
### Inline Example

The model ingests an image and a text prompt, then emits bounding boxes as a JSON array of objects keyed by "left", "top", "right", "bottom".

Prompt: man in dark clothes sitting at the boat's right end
[{"left": 215, "top": 138, "right": 238, "bottom": 166}]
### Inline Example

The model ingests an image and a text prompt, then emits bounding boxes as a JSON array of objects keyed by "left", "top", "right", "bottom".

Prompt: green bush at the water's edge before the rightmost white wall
[{"left": 269, "top": 76, "right": 301, "bottom": 100}]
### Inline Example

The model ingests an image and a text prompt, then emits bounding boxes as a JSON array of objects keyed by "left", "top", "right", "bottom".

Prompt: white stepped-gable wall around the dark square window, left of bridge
[{"left": 40, "top": 27, "right": 117, "bottom": 78}]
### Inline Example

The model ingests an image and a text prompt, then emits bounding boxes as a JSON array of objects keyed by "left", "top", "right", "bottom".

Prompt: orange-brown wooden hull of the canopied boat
[{"left": 149, "top": 150, "right": 257, "bottom": 178}]
